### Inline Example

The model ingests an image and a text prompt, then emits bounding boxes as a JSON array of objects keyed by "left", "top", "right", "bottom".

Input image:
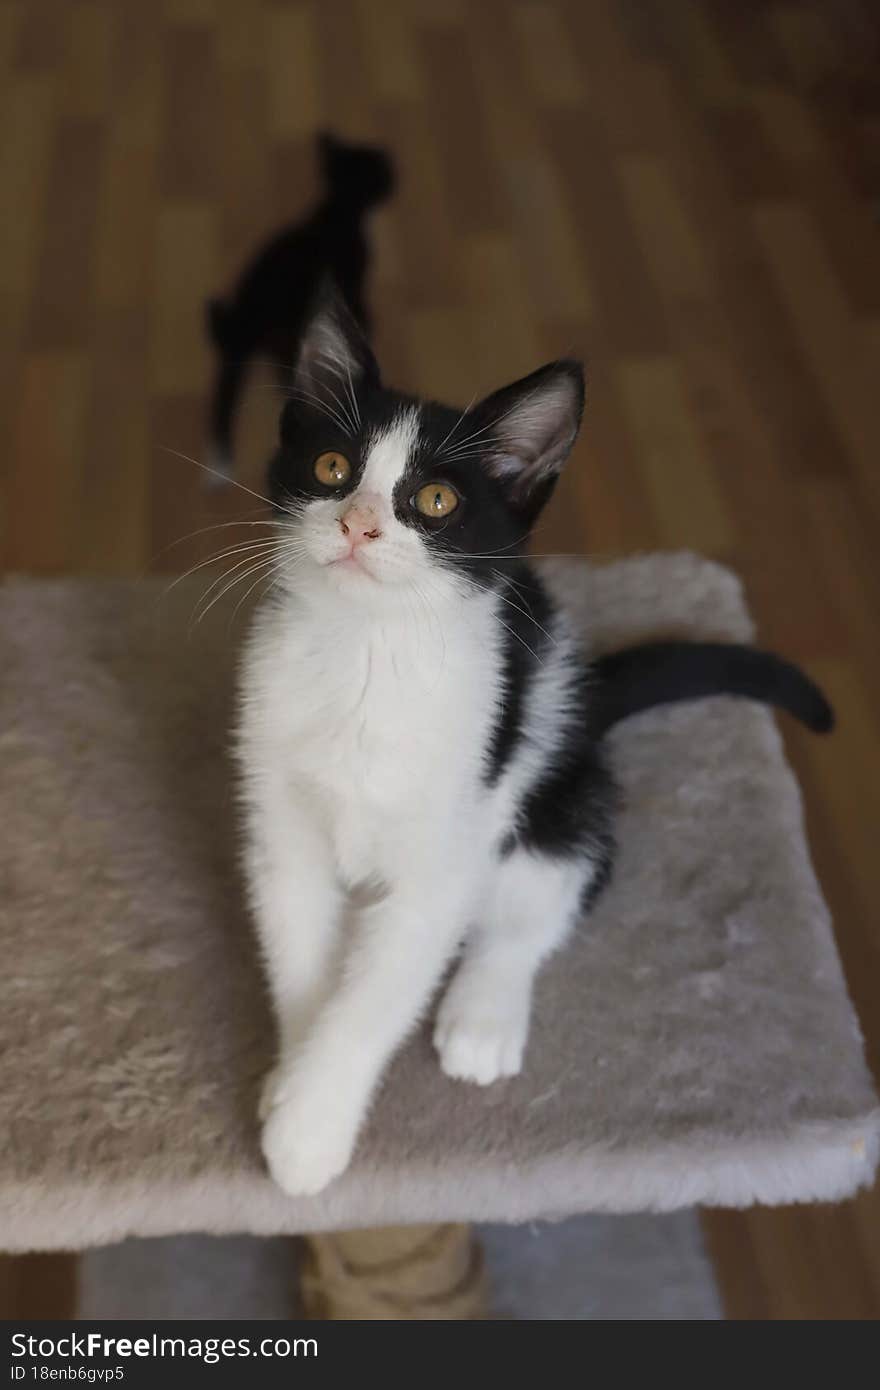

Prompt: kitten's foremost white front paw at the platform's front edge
[{"left": 263, "top": 1068, "right": 359, "bottom": 1197}]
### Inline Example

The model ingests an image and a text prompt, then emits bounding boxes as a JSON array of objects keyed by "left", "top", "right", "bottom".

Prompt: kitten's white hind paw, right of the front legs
[{"left": 434, "top": 999, "right": 528, "bottom": 1086}]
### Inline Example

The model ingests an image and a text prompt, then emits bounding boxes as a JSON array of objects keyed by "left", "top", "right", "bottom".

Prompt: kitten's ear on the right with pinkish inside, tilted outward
[{"left": 474, "top": 357, "right": 584, "bottom": 521}]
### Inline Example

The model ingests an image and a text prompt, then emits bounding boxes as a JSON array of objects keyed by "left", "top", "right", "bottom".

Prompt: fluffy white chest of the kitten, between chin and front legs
[{"left": 236, "top": 597, "right": 494, "bottom": 880}]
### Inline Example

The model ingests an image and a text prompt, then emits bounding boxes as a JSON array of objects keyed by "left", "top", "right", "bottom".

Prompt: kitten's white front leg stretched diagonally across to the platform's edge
[{"left": 263, "top": 874, "right": 467, "bottom": 1194}]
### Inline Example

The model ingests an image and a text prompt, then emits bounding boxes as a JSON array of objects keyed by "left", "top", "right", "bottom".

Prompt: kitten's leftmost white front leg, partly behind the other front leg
[{"left": 245, "top": 770, "right": 342, "bottom": 1116}]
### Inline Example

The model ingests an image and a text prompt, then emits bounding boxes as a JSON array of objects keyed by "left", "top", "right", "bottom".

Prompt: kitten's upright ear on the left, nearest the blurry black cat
[{"left": 293, "top": 284, "right": 380, "bottom": 402}]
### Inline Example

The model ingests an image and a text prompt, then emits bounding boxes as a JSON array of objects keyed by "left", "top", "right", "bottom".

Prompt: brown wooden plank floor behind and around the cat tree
[{"left": 0, "top": 0, "right": 880, "bottom": 1319}]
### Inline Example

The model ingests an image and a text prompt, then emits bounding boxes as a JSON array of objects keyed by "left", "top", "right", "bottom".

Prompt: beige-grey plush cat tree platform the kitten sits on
[{"left": 0, "top": 555, "right": 880, "bottom": 1250}]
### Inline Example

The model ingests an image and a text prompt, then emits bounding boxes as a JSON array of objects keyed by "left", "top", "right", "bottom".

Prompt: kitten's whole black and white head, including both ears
[{"left": 270, "top": 298, "right": 582, "bottom": 607}]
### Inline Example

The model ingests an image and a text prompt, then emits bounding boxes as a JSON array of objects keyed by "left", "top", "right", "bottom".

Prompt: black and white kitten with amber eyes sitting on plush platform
[{"left": 238, "top": 290, "right": 831, "bottom": 1193}]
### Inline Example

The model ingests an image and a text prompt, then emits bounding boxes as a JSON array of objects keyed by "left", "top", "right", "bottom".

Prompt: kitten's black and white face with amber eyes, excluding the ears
[{"left": 271, "top": 389, "right": 528, "bottom": 600}]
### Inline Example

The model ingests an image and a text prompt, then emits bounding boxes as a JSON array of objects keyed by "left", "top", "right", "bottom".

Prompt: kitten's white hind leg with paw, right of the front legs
[{"left": 434, "top": 849, "right": 594, "bottom": 1086}]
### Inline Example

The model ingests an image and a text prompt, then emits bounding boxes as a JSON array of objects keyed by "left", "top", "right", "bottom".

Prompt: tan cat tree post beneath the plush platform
[{"left": 300, "top": 1225, "right": 488, "bottom": 1322}]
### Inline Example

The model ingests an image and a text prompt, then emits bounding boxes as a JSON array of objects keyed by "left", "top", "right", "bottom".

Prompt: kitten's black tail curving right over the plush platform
[{"left": 591, "top": 642, "right": 834, "bottom": 738}]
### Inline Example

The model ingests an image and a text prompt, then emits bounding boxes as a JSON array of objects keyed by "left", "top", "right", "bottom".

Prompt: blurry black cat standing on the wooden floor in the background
[{"left": 207, "top": 133, "right": 395, "bottom": 474}]
